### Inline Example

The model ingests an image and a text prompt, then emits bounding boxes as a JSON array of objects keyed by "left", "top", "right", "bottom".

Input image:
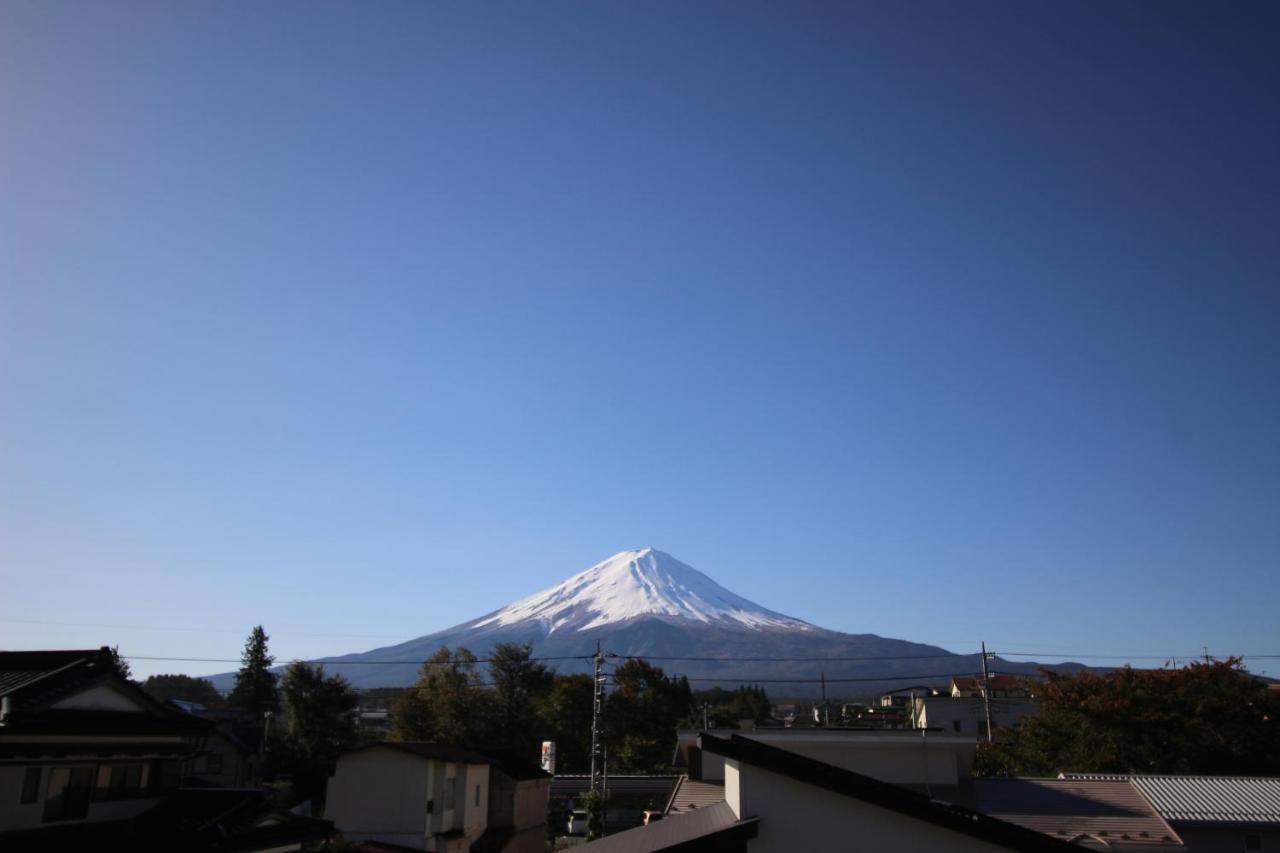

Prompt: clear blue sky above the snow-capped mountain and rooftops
[{"left": 0, "top": 0, "right": 1280, "bottom": 674}]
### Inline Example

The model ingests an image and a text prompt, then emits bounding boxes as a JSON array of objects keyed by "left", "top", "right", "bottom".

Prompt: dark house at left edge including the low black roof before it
[{"left": 0, "top": 648, "right": 333, "bottom": 853}]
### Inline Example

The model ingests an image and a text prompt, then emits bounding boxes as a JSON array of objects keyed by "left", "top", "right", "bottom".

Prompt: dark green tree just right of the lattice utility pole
[{"left": 605, "top": 658, "right": 694, "bottom": 774}]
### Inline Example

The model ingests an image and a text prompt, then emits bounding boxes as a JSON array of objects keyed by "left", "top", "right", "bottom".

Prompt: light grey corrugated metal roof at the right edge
[{"left": 1064, "top": 774, "right": 1280, "bottom": 824}]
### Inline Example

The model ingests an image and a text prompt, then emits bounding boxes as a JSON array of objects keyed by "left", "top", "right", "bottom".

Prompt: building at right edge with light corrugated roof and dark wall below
[{"left": 1061, "top": 774, "right": 1280, "bottom": 853}]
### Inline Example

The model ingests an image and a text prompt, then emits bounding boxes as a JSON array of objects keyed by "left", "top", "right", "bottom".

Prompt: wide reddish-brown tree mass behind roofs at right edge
[{"left": 975, "top": 658, "right": 1280, "bottom": 776}]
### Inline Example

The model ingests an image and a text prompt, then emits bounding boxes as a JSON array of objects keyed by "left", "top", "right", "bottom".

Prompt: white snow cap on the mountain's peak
[{"left": 471, "top": 548, "right": 815, "bottom": 634}]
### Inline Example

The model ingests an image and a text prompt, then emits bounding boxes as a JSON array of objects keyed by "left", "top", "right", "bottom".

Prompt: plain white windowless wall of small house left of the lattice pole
[{"left": 324, "top": 748, "right": 434, "bottom": 849}]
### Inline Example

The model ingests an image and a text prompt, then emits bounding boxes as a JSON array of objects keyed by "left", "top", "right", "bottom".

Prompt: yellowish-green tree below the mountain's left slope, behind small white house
[{"left": 392, "top": 647, "right": 489, "bottom": 747}]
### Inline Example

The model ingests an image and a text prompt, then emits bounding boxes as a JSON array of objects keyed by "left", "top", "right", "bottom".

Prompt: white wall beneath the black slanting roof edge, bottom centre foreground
[{"left": 724, "top": 761, "right": 1024, "bottom": 853}]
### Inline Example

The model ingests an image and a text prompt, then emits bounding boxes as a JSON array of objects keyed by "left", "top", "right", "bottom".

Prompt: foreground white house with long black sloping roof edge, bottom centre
[{"left": 584, "top": 734, "right": 1079, "bottom": 853}]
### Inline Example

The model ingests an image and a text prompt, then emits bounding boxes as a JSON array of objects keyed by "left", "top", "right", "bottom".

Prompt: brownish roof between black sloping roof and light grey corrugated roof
[{"left": 974, "top": 779, "right": 1183, "bottom": 850}]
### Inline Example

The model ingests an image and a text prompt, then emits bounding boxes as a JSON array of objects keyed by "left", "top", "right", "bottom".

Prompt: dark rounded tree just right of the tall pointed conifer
[{"left": 274, "top": 661, "right": 358, "bottom": 809}]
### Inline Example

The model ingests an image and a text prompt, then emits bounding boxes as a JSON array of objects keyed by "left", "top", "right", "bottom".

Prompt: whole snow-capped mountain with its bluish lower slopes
[{"left": 212, "top": 548, "right": 1084, "bottom": 697}]
